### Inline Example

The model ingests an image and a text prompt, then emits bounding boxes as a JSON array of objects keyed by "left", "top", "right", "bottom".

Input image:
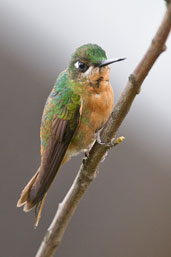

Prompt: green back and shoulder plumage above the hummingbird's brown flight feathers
[{"left": 40, "top": 71, "right": 80, "bottom": 154}]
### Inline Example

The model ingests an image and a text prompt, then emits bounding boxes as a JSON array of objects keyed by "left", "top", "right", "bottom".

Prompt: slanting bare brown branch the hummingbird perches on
[{"left": 36, "top": 4, "right": 171, "bottom": 257}]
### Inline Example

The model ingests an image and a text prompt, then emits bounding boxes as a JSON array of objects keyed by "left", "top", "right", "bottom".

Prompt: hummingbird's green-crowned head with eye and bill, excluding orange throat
[{"left": 68, "top": 44, "right": 123, "bottom": 81}]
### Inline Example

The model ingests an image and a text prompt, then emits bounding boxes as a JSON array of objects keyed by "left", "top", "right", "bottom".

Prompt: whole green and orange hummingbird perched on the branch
[{"left": 17, "top": 44, "right": 125, "bottom": 226}]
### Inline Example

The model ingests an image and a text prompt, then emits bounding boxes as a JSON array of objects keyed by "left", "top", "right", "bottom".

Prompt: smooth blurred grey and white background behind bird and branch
[{"left": 0, "top": 0, "right": 171, "bottom": 257}]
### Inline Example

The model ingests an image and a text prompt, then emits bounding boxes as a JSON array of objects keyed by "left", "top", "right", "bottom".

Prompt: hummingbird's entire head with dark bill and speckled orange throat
[{"left": 68, "top": 44, "right": 125, "bottom": 85}]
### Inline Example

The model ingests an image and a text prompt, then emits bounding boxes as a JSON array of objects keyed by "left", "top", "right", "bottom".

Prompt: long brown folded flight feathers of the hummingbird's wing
[{"left": 29, "top": 108, "right": 80, "bottom": 205}]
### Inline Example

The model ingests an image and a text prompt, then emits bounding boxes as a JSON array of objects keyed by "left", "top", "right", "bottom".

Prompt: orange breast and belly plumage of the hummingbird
[{"left": 64, "top": 85, "right": 113, "bottom": 162}]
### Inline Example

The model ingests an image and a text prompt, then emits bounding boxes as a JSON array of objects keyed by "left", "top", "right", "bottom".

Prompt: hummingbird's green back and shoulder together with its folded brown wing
[{"left": 29, "top": 72, "right": 80, "bottom": 206}]
